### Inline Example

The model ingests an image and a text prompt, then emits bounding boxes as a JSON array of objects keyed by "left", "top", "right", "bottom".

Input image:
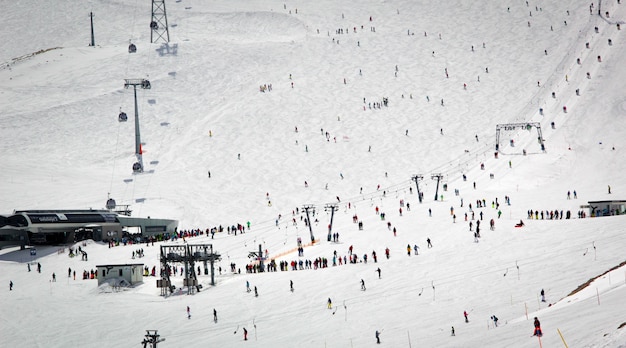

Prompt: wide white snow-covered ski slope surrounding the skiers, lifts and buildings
[{"left": 0, "top": 0, "right": 626, "bottom": 347}]
